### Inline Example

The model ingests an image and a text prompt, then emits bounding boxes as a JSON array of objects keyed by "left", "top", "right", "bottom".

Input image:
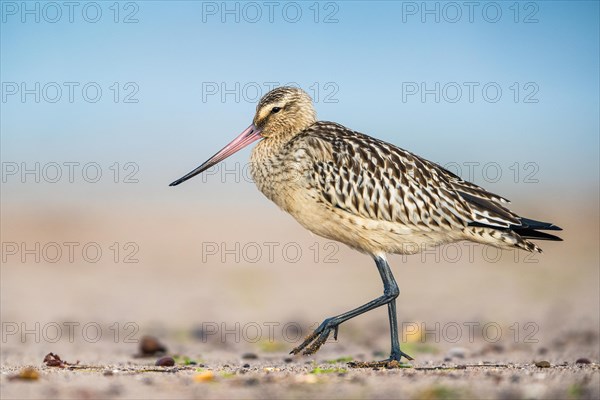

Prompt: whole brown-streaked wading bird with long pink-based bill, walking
[{"left": 171, "top": 87, "right": 561, "bottom": 364}]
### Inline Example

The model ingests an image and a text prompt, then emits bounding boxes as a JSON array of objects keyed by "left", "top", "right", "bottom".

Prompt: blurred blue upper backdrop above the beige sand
[{"left": 0, "top": 1, "right": 600, "bottom": 198}]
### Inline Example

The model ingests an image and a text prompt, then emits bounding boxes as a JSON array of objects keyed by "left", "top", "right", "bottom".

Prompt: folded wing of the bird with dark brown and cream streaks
[{"left": 292, "top": 122, "right": 521, "bottom": 230}]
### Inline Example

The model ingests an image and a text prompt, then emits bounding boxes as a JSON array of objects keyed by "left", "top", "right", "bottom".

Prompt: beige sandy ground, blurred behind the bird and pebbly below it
[{"left": 0, "top": 196, "right": 600, "bottom": 399}]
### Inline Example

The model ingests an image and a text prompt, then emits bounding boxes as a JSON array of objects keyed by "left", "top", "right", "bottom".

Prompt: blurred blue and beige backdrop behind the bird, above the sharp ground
[{"left": 0, "top": 1, "right": 600, "bottom": 365}]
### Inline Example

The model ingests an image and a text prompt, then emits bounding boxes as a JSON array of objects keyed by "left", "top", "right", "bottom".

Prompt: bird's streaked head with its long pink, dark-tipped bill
[{"left": 169, "top": 86, "right": 316, "bottom": 186}]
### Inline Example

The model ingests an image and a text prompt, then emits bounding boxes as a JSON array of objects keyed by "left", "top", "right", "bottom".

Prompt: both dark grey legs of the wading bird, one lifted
[{"left": 291, "top": 257, "right": 413, "bottom": 361}]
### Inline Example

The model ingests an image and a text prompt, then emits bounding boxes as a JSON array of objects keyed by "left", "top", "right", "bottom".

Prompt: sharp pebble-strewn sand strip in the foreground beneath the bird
[{"left": 2, "top": 333, "right": 600, "bottom": 399}]
